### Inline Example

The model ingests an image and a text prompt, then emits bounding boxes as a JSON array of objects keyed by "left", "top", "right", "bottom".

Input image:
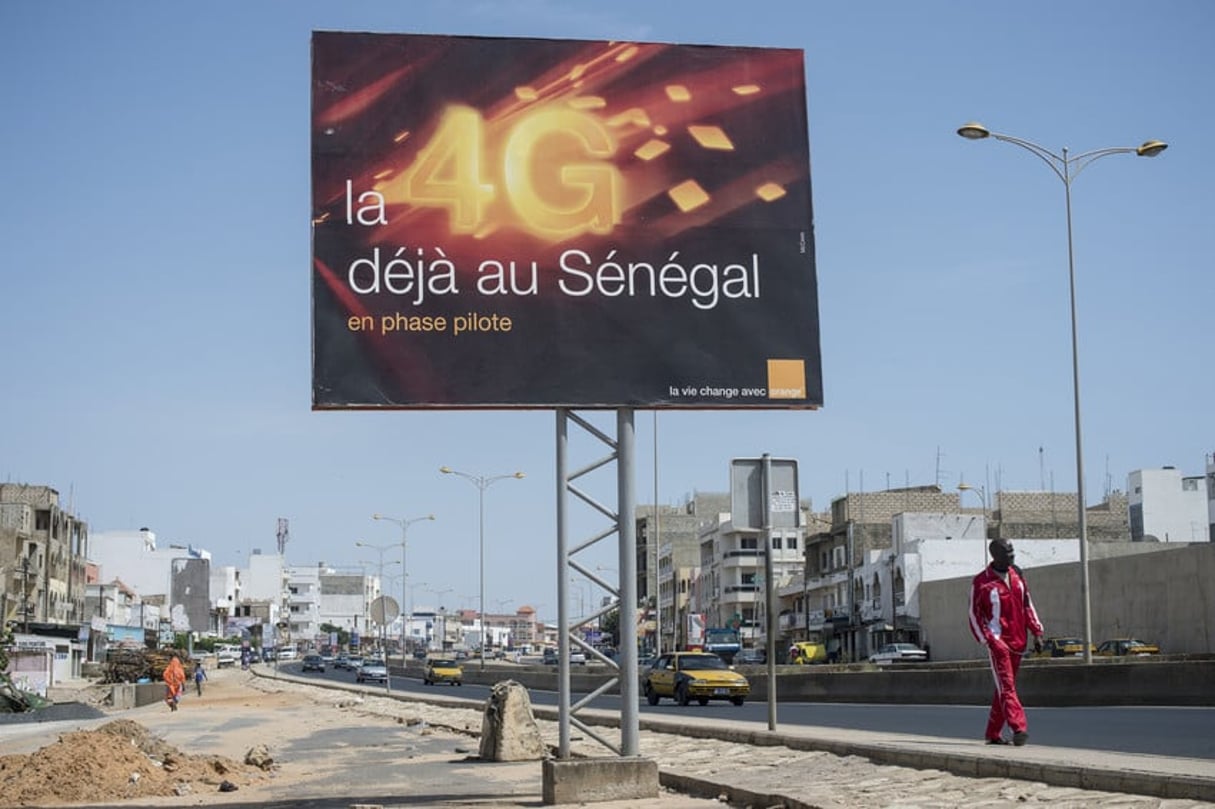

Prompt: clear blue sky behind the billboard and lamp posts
[{"left": 0, "top": 0, "right": 1215, "bottom": 617}]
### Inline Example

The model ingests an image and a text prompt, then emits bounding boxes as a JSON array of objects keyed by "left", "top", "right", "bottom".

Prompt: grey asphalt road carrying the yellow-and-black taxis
[{"left": 294, "top": 662, "right": 1215, "bottom": 759}]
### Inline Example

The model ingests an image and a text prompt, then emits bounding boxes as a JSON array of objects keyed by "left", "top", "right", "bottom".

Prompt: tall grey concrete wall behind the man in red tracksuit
[{"left": 920, "top": 543, "right": 1215, "bottom": 661}]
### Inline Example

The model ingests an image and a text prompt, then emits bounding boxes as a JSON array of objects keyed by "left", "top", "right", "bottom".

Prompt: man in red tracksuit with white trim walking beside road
[{"left": 970, "top": 539, "right": 1042, "bottom": 746}]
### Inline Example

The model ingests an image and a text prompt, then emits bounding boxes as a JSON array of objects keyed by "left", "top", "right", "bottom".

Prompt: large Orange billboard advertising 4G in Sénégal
[{"left": 311, "top": 32, "right": 823, "bottom": 409}]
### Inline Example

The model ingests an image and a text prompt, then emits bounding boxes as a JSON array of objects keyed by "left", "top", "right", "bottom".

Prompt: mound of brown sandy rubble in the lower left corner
[{"left": 0, "top": 719, "right": 259, "bottom": 807}]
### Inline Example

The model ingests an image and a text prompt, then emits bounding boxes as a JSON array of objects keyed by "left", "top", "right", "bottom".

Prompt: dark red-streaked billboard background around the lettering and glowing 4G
[{"left": 312, "top": 33, "right": 823, "bottom": 409}]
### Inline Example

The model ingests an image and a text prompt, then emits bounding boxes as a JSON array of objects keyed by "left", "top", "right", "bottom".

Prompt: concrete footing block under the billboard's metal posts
[{"left": 542, "top": 758, "right": 659, "bottom": 805}]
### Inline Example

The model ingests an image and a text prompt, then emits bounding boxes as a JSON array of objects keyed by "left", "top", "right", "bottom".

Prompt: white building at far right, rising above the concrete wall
[{"left": 1126, "top": 466, "right": 1211, "bottom": 542}]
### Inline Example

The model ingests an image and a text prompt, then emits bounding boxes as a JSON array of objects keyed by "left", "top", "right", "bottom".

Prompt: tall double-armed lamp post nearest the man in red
[{"left": 957, "top": 121, "right": 1169, "bottom": 663}]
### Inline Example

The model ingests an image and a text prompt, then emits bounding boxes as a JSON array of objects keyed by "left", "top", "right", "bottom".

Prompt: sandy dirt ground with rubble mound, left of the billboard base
[{"left": 0, "top": 669, "right": 720, "bottom": 809}]
